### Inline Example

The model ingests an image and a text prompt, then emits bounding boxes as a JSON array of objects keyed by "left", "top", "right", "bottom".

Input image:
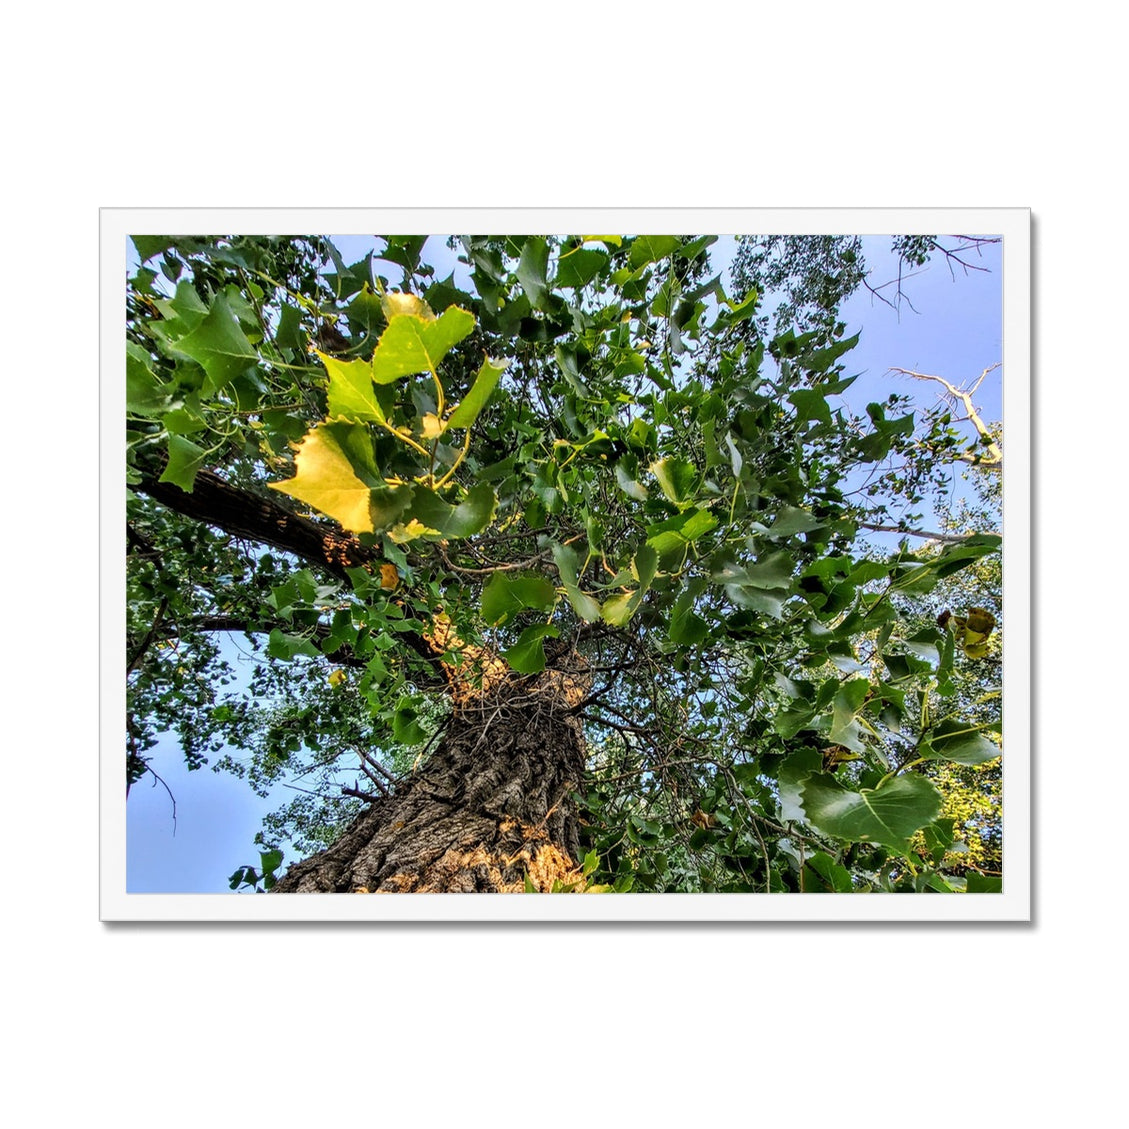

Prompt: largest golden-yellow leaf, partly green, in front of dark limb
[{"left": 268, "top": 423, "right": 381, "bottom": 533}]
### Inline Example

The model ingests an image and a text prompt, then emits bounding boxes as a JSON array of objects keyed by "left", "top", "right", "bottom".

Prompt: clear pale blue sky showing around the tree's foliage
[{"left": 126, "top": 233, "right": 1004, "bottom": 893}]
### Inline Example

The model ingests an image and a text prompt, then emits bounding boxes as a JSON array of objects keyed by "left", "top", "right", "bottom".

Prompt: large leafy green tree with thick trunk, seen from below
[{"left": 126, "top": 235, "right": 999, "bottom": 892}]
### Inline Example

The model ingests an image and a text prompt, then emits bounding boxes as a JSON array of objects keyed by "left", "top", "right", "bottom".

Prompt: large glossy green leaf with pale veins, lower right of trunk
[{"left": 802, "top": 773, "right": 940, "bottom": 851}]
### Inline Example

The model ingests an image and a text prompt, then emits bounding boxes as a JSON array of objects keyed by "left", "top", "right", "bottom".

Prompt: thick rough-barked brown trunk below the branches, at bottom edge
[{"left": 273, "top": 656, "right": 588, "bottom": 893}]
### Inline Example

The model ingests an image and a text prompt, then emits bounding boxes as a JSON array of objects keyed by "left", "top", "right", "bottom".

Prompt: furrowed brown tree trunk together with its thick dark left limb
[{"left": 139, "top": 466, "right": 590, "bottom": 893}]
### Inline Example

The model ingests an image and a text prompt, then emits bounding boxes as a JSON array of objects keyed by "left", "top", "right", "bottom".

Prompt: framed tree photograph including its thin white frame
[{"left": 102, "top": 209, "right": 1030, "bottom": 920}]
